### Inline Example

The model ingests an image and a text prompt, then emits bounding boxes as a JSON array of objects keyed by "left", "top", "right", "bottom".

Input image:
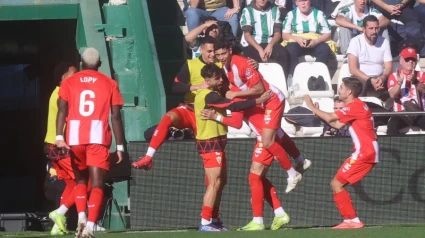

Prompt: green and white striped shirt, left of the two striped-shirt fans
[{"left": 240, "top": 1, "right": 282, "bottom": 44}]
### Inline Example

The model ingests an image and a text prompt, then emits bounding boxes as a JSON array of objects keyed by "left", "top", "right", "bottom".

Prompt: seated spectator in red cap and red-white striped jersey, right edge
[{"left": 387, "top": 47, "right": 425, "bottom": 135}]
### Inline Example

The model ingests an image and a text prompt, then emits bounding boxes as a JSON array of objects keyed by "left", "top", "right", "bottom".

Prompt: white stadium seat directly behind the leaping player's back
[{"left": 258, "top": 63, "right": 289, "bottom": 98}]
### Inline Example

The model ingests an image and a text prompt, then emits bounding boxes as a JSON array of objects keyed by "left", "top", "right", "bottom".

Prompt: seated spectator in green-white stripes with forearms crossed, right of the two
[{"left": 282, "top": 0, "right": 331, "bottom": 79}]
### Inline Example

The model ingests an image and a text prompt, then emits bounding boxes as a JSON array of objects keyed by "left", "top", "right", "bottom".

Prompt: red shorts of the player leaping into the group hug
[{"left": 263, "top": 95, "right": 285, "bottom": 130}]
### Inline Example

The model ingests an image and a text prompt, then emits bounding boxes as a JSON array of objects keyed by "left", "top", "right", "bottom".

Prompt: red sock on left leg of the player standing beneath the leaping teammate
[{"left": 248, "top": 173, "right": 264, "bottom": 217}]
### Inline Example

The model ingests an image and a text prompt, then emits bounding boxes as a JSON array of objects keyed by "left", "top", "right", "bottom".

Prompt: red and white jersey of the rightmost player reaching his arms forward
[{"left": 335, "top": 98, "right": 379, "bottom": 163}]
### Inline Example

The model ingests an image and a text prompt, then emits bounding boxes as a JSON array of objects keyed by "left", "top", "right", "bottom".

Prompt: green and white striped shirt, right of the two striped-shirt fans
[{"left": 282, "top": 8, "right": 331, "bottom": 34}]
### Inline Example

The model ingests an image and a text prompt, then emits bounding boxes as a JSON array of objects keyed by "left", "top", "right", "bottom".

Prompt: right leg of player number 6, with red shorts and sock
[{"left": 83, "top": 145, "right": 109, "bottom": 237}]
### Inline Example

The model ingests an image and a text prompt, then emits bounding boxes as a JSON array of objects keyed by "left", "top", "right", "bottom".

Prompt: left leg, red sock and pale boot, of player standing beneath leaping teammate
[{"left": 238, "top": 162, "right": 266, "bottom": 231}]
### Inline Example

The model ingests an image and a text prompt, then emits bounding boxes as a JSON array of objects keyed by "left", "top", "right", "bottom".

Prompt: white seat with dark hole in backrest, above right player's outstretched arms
[{"left": 293, "top": 62, "right": 334, "bottom": 98}]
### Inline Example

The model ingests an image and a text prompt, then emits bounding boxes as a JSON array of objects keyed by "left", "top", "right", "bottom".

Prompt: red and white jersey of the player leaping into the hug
[{"left": 223, "top": 55, "right": 285, "bottom": 103}]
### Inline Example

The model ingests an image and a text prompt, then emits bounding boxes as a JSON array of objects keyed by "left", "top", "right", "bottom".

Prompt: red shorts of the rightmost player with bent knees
[{"left": 335, "top": 158, "right": 375, "bottom": 184}]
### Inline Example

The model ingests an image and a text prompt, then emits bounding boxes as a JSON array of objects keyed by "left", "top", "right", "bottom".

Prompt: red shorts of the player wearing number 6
[{"left": 71, "top": 144, "right": 109, "bottom": 170}]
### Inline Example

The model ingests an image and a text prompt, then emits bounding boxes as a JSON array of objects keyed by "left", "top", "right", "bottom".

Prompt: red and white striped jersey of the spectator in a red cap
[{"left": 387, "top": 69, "right": 425, "bottom": 112}]
